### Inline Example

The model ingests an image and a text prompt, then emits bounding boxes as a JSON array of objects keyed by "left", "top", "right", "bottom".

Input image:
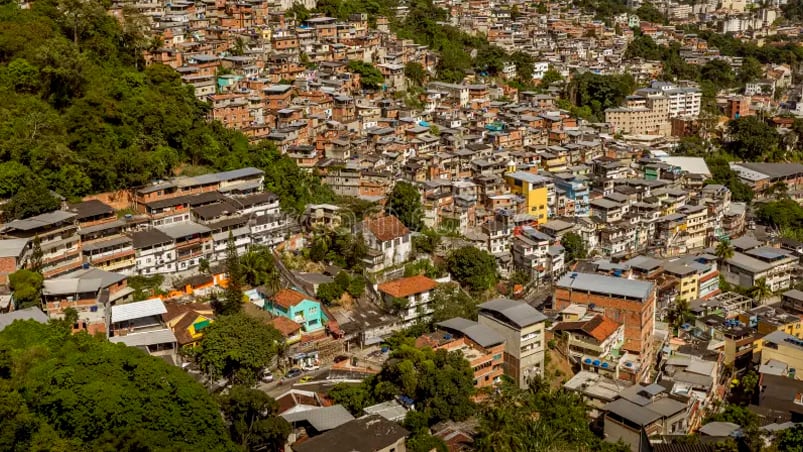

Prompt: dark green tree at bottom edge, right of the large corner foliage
[{"left": 220, "top": 385, "right": 292, "bottom": 451}]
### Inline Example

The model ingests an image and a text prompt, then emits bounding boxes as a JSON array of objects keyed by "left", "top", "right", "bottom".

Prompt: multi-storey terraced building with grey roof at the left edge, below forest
[{"left": 0, "top": 210, "right": 83, "bottom": 278}]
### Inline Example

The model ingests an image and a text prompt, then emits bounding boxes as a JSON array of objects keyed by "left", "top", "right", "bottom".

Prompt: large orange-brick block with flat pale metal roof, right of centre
[{"left": 553, "top": 272, "right": 655, "bottom": 375}]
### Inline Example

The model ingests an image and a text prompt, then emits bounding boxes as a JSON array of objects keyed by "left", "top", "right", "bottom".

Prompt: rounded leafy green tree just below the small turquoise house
[{"left": 196, "top": 313, "right": 282, "bottom": 385}]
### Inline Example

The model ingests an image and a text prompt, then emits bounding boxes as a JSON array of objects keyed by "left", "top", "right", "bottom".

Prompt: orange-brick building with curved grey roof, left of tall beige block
[{"left": 415, "top": 317, "right": 505, "bottom": 388}]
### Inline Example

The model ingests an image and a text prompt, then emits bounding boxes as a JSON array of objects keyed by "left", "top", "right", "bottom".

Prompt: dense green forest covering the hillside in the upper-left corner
[{"left": 0, "top": 0, "right": 332, "bottom": 217}]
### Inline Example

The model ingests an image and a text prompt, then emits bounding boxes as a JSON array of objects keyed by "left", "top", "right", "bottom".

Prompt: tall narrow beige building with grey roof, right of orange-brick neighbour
[{"left": 478, "top": 298, "right": 546, "bottom": 388}]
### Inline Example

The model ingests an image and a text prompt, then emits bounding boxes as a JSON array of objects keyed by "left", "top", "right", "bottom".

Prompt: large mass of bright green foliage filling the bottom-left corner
[{"left": 0, "top": 321, "right": 236, "bottom": 452}]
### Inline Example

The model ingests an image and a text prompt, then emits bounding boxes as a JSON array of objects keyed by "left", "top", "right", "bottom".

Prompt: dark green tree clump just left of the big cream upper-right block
[{"left": 569, "top": 72, "right": 636, "bottom": 119}]
